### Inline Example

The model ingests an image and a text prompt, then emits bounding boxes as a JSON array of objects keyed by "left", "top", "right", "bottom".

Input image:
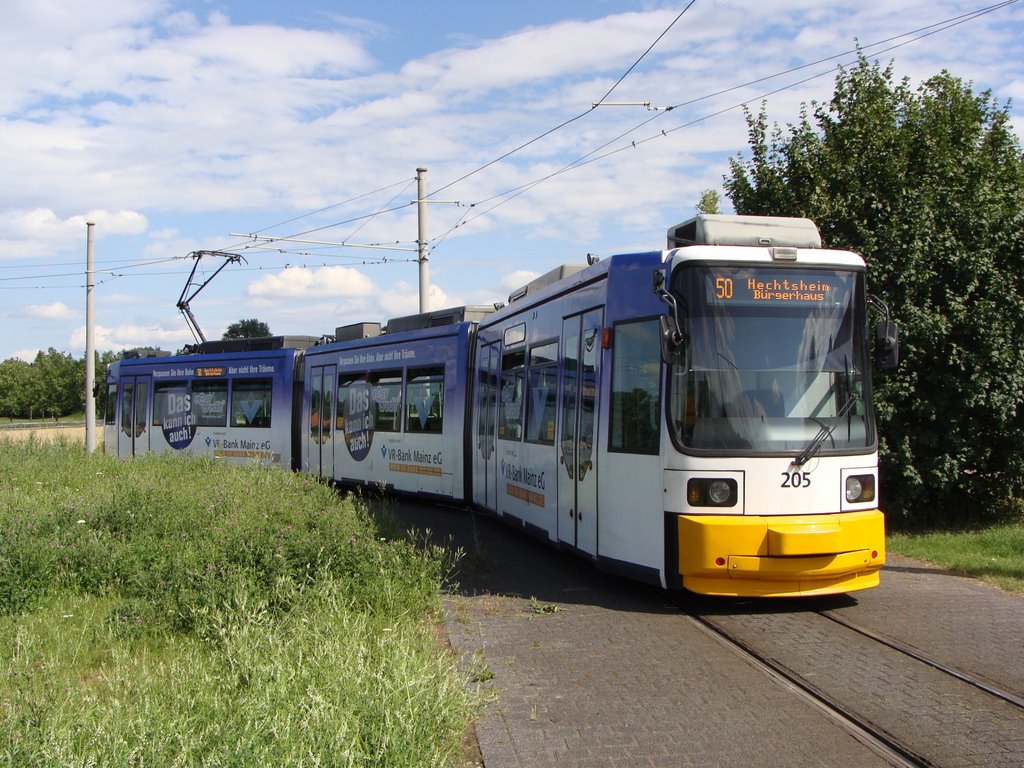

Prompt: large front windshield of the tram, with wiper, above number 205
[{"left": 669, "top": 265, "right": 874, "bottom": 455}]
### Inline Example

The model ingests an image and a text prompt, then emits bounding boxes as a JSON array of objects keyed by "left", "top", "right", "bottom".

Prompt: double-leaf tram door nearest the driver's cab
[{"left": 558, "top": 308, "right": 603, "bottom": 555}]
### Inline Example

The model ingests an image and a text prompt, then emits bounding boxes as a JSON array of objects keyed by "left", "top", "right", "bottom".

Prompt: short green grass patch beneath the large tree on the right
[{"left": 886, "top": 522, "right": 1024, "bottom": 593}]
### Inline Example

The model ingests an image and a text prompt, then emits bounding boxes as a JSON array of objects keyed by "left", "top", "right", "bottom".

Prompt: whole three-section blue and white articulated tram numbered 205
[{"left": 104, "top": 215, "right": 898, "bottom": 597}]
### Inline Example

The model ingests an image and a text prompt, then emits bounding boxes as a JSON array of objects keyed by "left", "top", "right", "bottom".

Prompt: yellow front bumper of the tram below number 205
[{"left": 677, "top": 510, "right": 886, "bottom": 597}]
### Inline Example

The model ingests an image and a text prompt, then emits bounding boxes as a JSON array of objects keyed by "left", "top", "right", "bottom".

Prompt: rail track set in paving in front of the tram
[{"left": 674, "top": 597, "right": 1024, "bottom": 768}]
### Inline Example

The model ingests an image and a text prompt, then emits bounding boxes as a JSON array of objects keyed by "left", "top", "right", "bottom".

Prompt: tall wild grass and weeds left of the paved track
[{"left": 0, "top": 437, "right": 475, "bottom": 767}]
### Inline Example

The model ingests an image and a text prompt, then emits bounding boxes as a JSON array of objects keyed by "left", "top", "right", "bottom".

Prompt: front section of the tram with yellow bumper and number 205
[{"left": 471, "top": 216, "right": 885, "bottom": 596}]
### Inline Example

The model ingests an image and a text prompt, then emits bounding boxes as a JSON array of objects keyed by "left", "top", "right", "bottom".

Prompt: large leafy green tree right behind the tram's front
[{"left": 725, "top": 56, "right": 1024, "bottom": 522}]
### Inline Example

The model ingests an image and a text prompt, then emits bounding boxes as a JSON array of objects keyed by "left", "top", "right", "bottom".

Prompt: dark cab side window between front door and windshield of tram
[{"left": 610, "top": 319, "right": 662, "bottom": 454}]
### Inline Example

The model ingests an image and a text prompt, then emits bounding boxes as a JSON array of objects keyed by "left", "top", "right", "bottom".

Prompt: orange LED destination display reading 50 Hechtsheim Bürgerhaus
[{"left": 705, "top": 267, "right": 852, "bottom": 306}]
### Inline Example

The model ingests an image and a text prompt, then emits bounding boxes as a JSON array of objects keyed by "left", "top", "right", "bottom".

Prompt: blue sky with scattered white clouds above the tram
[{"left": 0, "top": 0, "right": 1024, "bottom": 359}]
